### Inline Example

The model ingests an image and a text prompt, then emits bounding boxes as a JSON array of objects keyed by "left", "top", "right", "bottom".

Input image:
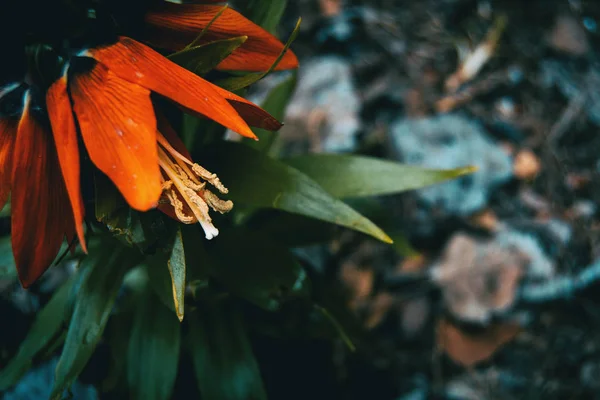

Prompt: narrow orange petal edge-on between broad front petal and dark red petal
[{"left": 46, "top": 76, "right": 87, "bottom": 253}]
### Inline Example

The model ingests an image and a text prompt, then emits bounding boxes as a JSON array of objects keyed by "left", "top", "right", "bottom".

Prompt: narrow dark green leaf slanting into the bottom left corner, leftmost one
[{"left": 0, "top": 277, "right": 74, "bottom": 392}]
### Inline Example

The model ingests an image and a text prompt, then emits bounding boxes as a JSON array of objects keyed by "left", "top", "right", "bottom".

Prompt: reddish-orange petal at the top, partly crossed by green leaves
[{"left": 146, "top": 2, "right": 298, "bottom": 71}]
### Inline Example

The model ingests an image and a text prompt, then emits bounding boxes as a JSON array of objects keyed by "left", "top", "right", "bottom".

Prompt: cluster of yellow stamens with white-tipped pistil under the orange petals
[{"left": 157, "top": 132, "right": 233, "bottom": 239}]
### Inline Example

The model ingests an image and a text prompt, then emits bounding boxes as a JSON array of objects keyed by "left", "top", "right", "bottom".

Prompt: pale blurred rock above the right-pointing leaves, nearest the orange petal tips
[{"left": 282, "top": 57, "right": 361, "bottom": 152}]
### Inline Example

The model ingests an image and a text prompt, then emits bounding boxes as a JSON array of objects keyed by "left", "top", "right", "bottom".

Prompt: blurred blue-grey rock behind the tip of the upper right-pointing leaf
[{"left": 390, "top": 114, "right": 512, "bottom": 216}]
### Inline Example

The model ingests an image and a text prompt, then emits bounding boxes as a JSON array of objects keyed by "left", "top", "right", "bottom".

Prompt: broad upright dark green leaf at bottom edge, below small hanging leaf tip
[{"left": 127, "top": 291, "right": 181, "bottom": 400}]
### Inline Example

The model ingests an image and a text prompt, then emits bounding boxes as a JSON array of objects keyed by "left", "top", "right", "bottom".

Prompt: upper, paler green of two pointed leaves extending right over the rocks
[{"left": 284, "top": 154, "right": 476, "bottom": 198}]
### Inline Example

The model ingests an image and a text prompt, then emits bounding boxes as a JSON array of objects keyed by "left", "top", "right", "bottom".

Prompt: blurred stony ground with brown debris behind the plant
[{"left": 0, "top": 0, "right": 600, "bottom": 400}]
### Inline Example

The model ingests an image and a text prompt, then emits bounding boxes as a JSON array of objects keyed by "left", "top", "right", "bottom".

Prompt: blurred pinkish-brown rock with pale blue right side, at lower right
[{"left": 432, "top": 228, "right": 555, "bottom": 324}]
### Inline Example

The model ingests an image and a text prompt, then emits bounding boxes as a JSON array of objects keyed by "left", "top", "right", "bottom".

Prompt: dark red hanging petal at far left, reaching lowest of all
[{"left": 11, "top": 93, "right": 72, "bottom": 287}]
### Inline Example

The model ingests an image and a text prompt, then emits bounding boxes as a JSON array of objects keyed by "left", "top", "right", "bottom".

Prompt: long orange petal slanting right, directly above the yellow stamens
[{"left": 87, "top": 37, "right": 255, "bottom": 138}]
